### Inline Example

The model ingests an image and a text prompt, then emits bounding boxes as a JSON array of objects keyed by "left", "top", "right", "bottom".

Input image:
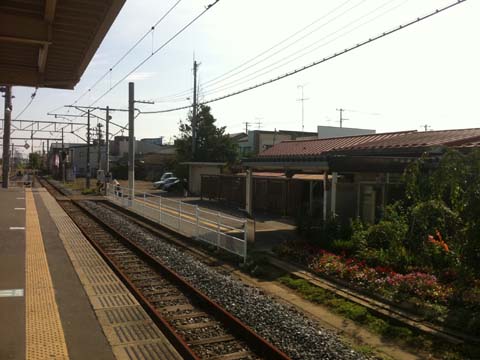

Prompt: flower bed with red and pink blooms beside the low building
[{"left": 275, "top": 241, "right": 480, "bottom": 336}]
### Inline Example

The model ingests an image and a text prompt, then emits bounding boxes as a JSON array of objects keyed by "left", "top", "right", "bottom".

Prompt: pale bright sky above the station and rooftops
[{"left": 4, "top": 0, "right": 480, "bottom": 155}]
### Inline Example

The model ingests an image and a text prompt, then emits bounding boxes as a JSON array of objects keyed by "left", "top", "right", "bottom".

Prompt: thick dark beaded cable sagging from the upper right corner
[{"left": 141, "top": 0, "right": 467, "bottom": 114}]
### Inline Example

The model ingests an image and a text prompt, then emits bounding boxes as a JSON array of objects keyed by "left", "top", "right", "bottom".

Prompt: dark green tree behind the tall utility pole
[{"left": 175, "top": 105, "right": 237, "bottom": 164}]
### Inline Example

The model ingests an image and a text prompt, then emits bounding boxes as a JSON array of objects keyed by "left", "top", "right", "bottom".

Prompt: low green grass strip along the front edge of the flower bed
[{"left": 277, "top": 275, "right": 480, "bottom": 360}]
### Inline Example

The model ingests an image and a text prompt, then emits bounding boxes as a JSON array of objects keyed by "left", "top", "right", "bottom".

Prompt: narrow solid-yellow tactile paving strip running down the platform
[{"left": 25, "top": 189, "right": 69, "bottom": 360}]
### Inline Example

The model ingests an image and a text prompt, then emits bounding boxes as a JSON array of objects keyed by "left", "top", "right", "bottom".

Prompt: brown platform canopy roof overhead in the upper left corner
[{"left": 0, "top": 0, "right": 125, "bottom": 89}]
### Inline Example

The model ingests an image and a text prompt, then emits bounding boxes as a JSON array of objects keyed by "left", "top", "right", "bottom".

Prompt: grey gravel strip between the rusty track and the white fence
[{"left": 83, "top": 201, "right": 366, "bottom": 360}]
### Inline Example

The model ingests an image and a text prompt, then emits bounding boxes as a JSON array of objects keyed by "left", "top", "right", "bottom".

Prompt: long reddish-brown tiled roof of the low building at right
[{"left": 259, "top": 128, "right": 480, "bottom": 158}]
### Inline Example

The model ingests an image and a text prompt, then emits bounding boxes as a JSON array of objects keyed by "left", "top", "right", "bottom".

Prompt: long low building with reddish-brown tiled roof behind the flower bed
[{"left": 215, "top": 129, "right": 480, "bottom": 222}]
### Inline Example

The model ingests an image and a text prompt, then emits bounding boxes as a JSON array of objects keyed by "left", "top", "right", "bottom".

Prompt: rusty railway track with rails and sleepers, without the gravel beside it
[{"left": 38, "top": 181, "right": 288, "bottom": 360}]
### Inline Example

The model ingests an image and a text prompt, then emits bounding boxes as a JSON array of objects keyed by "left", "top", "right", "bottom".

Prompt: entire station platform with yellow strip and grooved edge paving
[{"left": 0, "top": 187, "right": 181, "bottom": 360}]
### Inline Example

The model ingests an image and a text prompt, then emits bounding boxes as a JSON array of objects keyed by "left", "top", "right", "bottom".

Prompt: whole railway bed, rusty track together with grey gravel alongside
[{"left": 41, "top": 180, "right": 372, "bottom": 360}]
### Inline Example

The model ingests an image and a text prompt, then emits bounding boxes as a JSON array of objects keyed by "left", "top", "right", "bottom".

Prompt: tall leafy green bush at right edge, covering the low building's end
[{"left": 405, "top": 150, "right": 480, "bottom": 275}]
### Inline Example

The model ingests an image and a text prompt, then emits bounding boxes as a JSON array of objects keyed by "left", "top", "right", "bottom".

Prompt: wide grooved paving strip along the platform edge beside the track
[{"left": 40, "top": 192, "right": 182, "bottom": 360}]
